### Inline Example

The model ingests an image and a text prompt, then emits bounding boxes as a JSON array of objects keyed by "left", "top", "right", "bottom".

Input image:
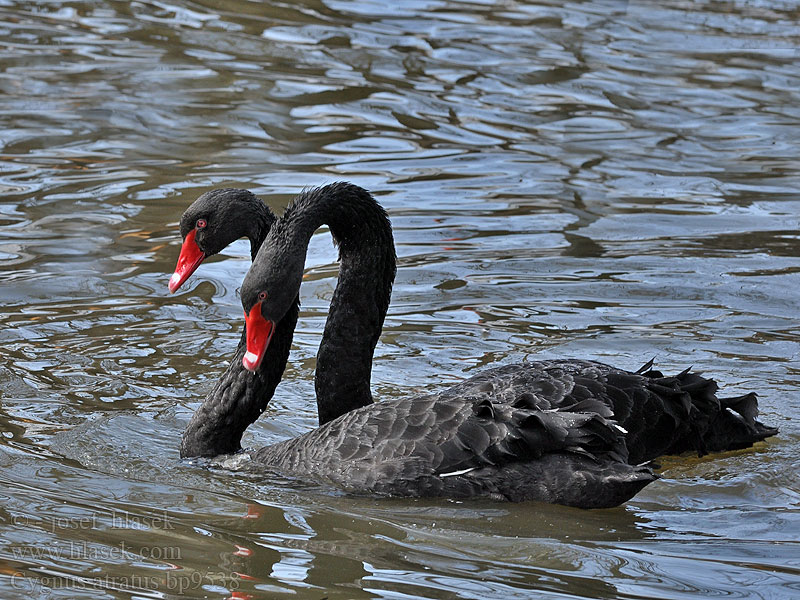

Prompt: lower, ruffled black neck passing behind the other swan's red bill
[{"left": 181, "top": 195, "right": 300, "bottom": 458}]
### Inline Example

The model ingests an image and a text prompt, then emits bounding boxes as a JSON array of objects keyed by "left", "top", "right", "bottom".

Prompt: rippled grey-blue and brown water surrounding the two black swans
[{"left": 0, "top": 0, "right": 800, "bottom": 599}]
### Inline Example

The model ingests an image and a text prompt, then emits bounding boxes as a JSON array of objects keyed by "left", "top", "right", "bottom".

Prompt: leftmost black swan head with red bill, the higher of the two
[{"left": 169, "top": 188, "right": 275, "bottom": 292}]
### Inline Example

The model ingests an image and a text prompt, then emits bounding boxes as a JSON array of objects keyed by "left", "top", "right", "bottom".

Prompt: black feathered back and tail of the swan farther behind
[{"left": 432, "top": 359, "right": 778, "bottom": 464}]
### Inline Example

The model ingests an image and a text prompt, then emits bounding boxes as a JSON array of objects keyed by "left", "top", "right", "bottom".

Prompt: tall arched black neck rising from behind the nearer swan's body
[{"left": 276, "top": 182, "right": 397, "bottom": 425}]
